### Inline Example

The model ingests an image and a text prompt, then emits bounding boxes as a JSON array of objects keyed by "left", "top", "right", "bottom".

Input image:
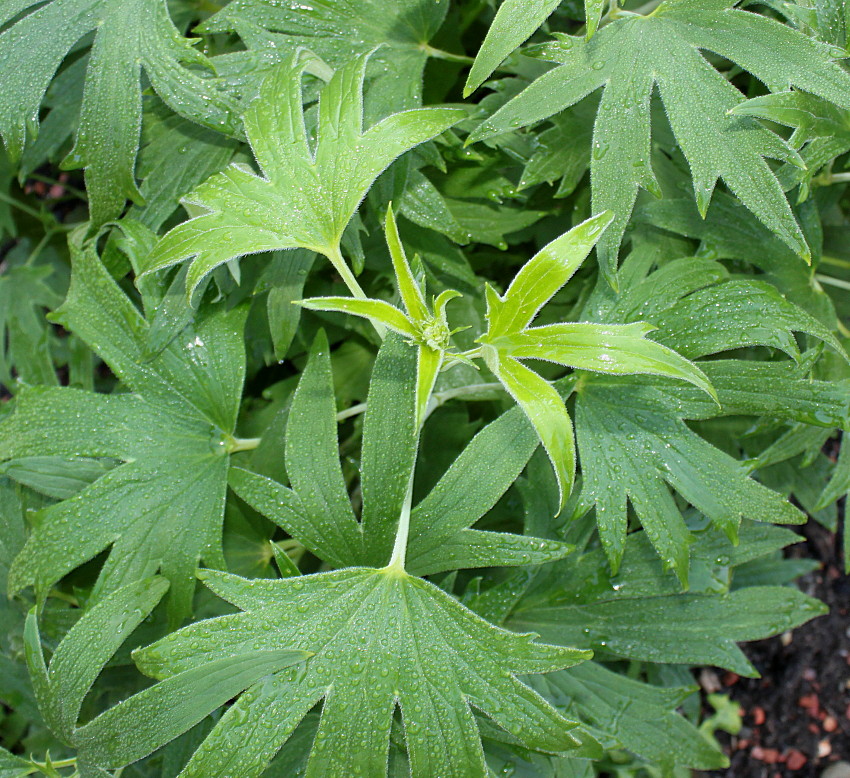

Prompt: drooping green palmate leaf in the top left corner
[{"left": 0, "top": 0, "right": 237, "bottom": 227}]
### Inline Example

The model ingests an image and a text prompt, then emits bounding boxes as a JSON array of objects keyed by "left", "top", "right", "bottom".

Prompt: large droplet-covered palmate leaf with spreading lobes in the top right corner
[{"left": 470, "top": 0, "right": 850, "bottom": 281}]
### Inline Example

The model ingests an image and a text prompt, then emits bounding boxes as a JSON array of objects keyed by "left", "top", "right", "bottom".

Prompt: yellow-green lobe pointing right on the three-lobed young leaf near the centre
[{"left": 492, "top": 322, "right": 717, "bottom": 398}]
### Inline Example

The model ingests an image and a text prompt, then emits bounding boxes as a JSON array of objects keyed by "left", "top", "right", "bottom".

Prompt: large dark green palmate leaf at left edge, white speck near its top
[{"left": 0, "top": 249, "right": 245, "bottom": 620}]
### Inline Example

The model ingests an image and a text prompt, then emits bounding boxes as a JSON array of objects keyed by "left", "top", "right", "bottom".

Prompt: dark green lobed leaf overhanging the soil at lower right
[{"left": 507, "top": 523, "right": 826, "bottom": 677}]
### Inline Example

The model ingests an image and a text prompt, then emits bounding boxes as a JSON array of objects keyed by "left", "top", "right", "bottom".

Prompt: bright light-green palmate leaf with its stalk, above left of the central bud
[{"left": 145, "top": 54, "right": 464, "bottom": 296}]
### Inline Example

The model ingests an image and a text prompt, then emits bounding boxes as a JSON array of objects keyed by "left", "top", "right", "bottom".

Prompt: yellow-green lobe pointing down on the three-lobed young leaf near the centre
[{"left": 482, "top": 346, "right": 576, "bottom": 508}]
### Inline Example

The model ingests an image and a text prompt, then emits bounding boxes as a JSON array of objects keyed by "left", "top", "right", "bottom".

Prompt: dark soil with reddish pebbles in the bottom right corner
[{"left": 710, "top": 511, "right": 850, "bottom": 778}]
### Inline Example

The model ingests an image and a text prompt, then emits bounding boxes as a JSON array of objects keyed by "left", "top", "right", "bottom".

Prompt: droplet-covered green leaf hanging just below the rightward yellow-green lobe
[{"left": 576, "top": 376, "right": 804, "bottom": 584}]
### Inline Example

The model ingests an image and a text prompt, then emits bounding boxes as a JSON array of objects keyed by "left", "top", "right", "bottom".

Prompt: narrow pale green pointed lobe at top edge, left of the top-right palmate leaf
[{"left": 463, "top": 0, "right": 560, "bottom": 97}]
